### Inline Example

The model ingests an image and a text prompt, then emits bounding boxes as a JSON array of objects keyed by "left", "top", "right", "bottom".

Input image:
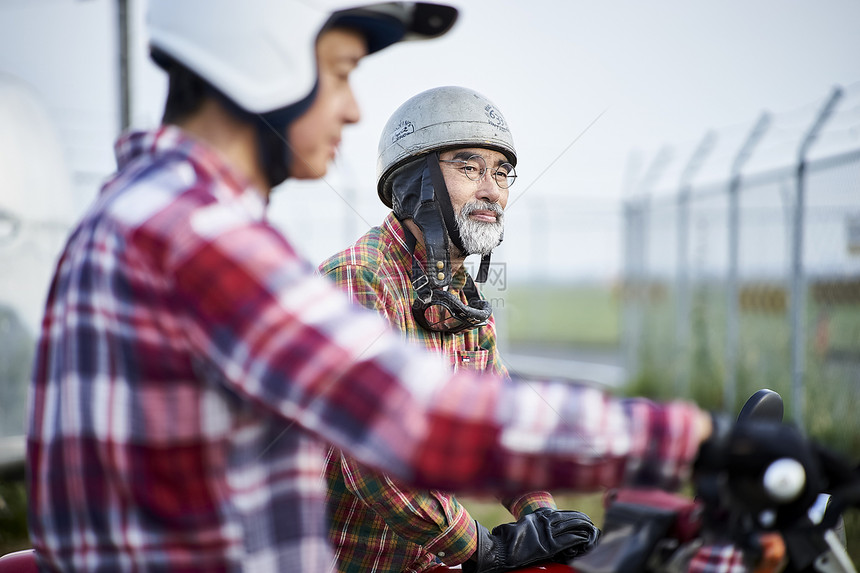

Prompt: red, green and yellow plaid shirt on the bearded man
[{"left": 320, "top": 214, "right": 555, "bottom": 573}]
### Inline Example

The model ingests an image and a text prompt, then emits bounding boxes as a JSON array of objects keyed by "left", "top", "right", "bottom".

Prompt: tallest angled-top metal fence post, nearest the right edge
[{"left": 789, "top": 86, "right": 842, "bottom": 428}]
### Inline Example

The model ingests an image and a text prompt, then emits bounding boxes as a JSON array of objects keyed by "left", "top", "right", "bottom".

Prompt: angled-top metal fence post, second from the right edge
[{"left": 723, "top": 111, "right": 770, "bottom": 412}]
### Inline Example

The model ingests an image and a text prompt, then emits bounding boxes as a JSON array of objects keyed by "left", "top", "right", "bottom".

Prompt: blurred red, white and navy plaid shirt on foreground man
[{"left": 27, "top": 127, "right": 699, "bottom": 572}]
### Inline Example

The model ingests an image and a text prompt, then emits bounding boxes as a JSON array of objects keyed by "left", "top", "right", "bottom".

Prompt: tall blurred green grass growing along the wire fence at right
[{"left": 626, "top": 285, "right": 860, "bottom": 562}]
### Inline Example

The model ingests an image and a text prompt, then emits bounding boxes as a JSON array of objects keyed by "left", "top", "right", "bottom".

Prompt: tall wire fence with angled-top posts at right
[{"left": 623, "top": 84, "right": 860, "bottom": 452}]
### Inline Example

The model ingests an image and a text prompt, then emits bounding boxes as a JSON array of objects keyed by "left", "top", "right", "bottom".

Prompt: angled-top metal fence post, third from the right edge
[{"left": 675, "top": 130, "right": 717, "bottom": 396}]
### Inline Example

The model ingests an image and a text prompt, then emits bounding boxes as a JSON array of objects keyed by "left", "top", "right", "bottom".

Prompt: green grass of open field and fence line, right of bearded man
[{"left": 494, "top": 284, "right": 860, "bottom": 562}]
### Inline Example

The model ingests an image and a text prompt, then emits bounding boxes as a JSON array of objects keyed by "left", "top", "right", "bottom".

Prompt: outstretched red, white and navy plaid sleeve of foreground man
[{"left": 166, "top": 211, "right": 699, "bottom": 500}]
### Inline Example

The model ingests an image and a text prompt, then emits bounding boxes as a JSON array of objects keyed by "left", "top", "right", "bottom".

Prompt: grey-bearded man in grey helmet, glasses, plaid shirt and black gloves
[{"left": 320, "top": 87, "right": 598, "bottom": 573}]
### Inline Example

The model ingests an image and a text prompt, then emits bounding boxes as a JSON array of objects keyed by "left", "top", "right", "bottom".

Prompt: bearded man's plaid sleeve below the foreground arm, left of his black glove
[{"left": 341, "top": 454, "right": 477, "bottom": 565}]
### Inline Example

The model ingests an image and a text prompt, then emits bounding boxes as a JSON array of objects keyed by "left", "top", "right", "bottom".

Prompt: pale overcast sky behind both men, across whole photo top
[{"left": 0, "top": 0, "right": 860, "bottom": 280}]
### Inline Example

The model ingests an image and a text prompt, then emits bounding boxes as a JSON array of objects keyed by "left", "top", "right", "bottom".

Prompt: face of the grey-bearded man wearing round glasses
[{"left": 439, "top": 147, "right": 508, "bottom": 254}]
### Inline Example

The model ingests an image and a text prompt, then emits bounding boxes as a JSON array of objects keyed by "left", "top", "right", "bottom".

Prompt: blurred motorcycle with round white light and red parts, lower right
[{"left": 0, "top": 390, "right": 860, "bottom": 573}]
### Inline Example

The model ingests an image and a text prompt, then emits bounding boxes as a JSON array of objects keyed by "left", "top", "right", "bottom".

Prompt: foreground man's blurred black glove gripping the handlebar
[{"left": 694, "top": 419, "right": 823, "bottom": 525}]
